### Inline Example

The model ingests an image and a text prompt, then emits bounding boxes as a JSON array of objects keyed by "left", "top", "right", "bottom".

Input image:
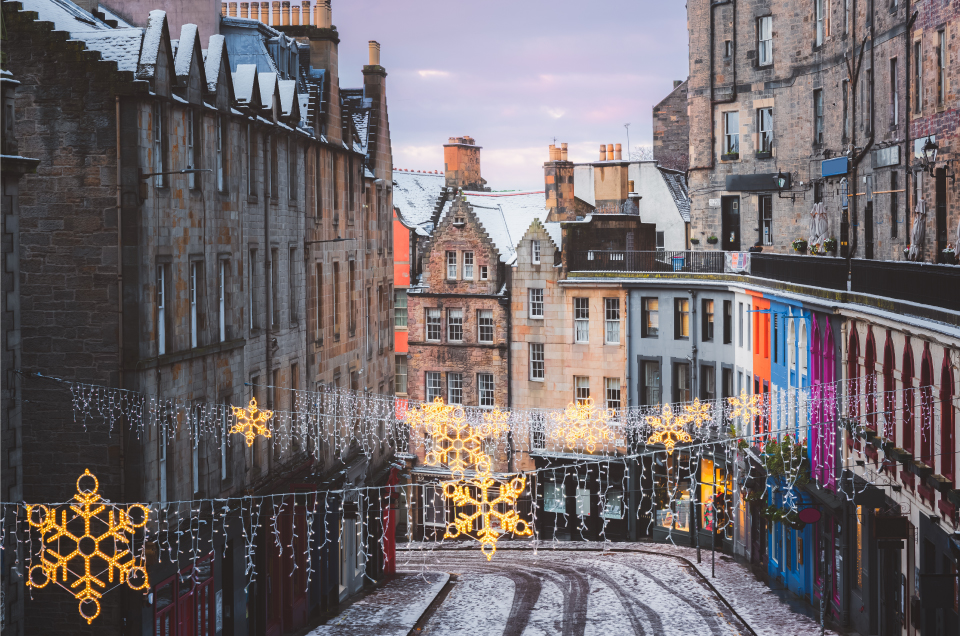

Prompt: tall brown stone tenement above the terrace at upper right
[{"left": 687, "top": 0, "right": 958, "bottom": 261}]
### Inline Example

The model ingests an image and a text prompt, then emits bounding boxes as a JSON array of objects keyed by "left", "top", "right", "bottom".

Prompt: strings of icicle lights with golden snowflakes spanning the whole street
[{"left": 0, "top": 370, "right": 956, "bottom": 623}]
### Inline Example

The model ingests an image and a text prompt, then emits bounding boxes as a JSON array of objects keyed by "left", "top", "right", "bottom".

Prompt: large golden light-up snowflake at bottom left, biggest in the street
[{"left": 27, "top": 470, "right": 150, "bottom": 625}]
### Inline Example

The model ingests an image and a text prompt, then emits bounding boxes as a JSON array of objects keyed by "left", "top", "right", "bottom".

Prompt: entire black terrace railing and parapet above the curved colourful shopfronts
[{"left": 567, "top": 250, "right": 960, "bottom": 311}]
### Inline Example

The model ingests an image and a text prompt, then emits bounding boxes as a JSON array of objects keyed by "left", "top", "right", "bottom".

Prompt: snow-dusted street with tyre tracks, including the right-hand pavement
[{"left": 398, "top": 543, "right": 833, "bottom": 636}]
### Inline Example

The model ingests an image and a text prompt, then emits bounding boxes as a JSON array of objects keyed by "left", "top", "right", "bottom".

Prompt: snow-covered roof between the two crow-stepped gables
[{"left": 440, "top": 190, "right": 547, "bottom": 264}]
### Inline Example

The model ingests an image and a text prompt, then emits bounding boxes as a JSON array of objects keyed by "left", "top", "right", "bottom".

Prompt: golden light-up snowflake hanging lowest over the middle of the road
[{"left": 443, "top": 471, "right": 533, "bottom": 561}]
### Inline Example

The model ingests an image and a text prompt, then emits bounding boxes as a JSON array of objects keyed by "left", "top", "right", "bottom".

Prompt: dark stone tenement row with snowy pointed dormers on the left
[{"left": 3, "top": 0, "right": 394, "bottom": 634}]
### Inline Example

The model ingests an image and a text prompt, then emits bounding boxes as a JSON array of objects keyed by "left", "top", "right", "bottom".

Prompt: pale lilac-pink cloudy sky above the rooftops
[{"left": 333, "top": 0, "right": 689, "bottom": 190}]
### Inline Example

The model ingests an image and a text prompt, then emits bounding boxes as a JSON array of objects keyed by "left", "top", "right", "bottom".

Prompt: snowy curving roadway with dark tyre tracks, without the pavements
[{"left": 408, "top": 550, "right": 756, "bottom": 636}]
